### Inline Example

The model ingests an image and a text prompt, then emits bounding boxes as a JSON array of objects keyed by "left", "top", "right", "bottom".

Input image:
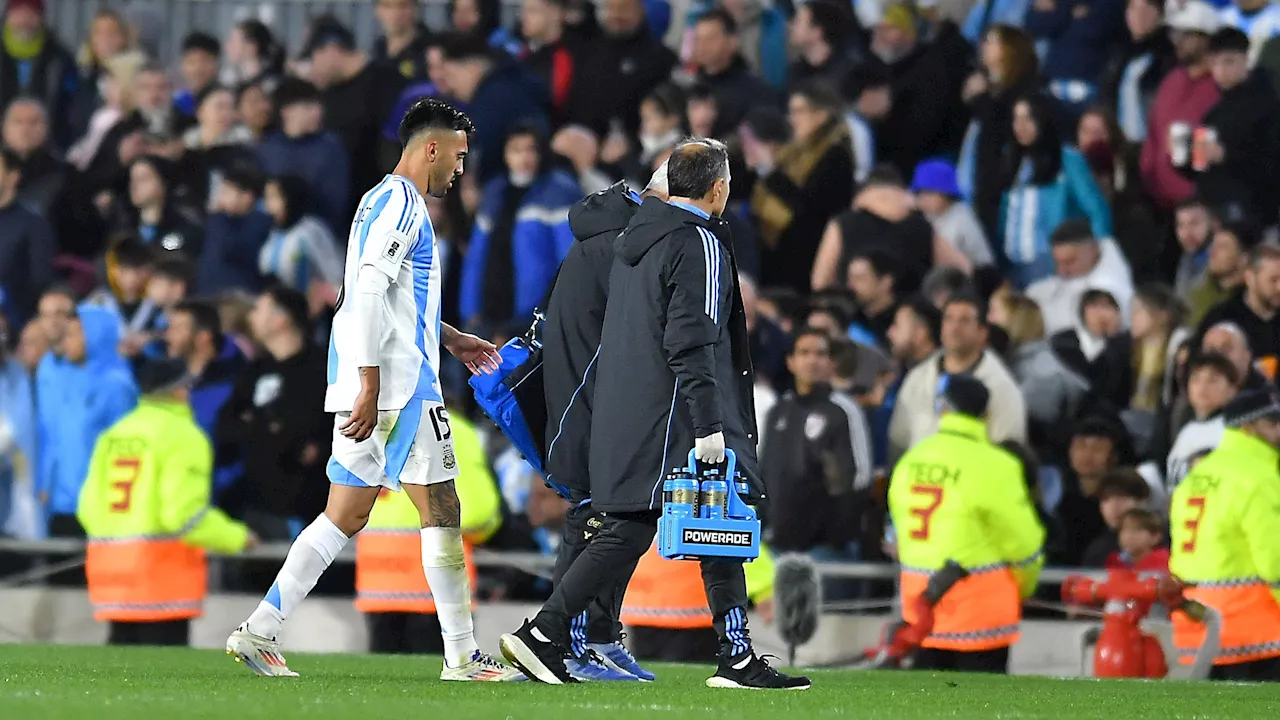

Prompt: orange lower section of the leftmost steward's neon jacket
[{"left": 84, "top": 536, "right": 209, "bottom": 623}]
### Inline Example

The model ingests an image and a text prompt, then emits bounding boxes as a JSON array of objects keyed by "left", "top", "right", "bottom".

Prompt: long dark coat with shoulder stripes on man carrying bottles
[{"left": 590, "top": 197, "right": 760, "bottom": 512}]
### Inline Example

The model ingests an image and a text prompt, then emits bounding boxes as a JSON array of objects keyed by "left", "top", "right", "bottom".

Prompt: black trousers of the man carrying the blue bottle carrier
[{"left": 534, "top": 510, "right": 751, "bottom": 659}]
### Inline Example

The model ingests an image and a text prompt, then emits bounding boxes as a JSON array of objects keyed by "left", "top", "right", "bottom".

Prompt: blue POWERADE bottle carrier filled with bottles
[{"left": 658, "top": 450, "right": 760, "bottom": 561}]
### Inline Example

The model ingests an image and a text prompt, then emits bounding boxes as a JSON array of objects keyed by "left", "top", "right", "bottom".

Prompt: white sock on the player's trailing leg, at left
[{"left": 246, "top": 512, "right": 349, "bottom": 638}]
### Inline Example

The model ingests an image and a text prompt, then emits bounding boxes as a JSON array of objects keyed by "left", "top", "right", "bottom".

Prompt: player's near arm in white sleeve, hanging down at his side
[{"left": 338, "top": 183, "right": 416, "bottom": 441}]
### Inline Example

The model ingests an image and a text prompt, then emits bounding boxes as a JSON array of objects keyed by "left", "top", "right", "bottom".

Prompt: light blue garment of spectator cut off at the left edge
[{"left": 0, "top": 322, "right": 44, "bottom": 539}]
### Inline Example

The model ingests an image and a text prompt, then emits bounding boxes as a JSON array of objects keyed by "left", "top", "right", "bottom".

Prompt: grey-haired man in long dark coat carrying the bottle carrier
[{"left": 502, "top": 140, "right": 809, "bottom": 688}]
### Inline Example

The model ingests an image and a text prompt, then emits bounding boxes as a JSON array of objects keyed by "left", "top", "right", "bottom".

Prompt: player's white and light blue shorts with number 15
[{"left": 325, "top": 398, "right": 458, "bottom": 491}]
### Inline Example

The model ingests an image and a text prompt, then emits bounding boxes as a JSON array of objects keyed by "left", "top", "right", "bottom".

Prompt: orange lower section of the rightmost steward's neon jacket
[{"left": 1172, "top": 577, "right": 1280, "bottom": 665}]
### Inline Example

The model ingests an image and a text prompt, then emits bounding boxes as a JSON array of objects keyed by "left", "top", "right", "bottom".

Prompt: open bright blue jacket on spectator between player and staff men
[{"left": 458, "top": 170, "right": 582, "bottom": 323}]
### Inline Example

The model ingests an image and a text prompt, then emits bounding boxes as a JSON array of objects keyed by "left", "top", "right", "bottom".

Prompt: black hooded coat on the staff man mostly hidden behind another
[{"left": 541, "top": 182, "right": 639, "bottom": 501}]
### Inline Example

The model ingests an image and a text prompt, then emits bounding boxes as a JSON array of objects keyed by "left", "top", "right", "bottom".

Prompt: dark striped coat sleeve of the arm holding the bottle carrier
[{"left": 662, "top": 229, "right": 732, "bottom": 438}]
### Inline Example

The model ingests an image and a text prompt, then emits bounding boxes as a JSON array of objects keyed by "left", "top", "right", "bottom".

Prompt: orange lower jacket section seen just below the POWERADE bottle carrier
[{"left": 621, "top": 546, "right": 712, "bottom": 630}]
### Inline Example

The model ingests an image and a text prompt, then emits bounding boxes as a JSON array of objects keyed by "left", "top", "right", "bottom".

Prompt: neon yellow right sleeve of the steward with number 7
[{"left": 978, "top": 461, "right": 1044, "bottom": 597}]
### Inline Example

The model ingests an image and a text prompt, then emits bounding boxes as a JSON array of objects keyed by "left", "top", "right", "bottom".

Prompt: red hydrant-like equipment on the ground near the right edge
[{"left": 1062, "top": 570, "right": 1183, "bottom": 678}]
